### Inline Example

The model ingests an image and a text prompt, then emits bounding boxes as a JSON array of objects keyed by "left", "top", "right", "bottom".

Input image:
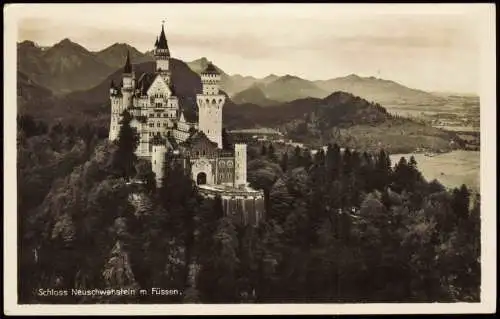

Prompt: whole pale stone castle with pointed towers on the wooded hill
[{"left": 109, "top": 25, "right": 264, "bottom": 224}]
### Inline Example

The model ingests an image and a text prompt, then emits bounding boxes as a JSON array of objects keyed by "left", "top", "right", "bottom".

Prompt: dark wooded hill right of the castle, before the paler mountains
[{"left": 223, "top": 92, "right": 463, "bottom": 153}]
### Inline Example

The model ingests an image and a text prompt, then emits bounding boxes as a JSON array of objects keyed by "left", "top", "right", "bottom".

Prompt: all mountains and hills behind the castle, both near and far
[{"left": 18, "top": 39, "right": 470, "bottom": 151}]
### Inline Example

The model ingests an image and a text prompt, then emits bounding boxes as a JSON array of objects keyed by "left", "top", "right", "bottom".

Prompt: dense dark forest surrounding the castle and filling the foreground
[{"left": 17, "top": 116, "right": 481, "bottom": 303}]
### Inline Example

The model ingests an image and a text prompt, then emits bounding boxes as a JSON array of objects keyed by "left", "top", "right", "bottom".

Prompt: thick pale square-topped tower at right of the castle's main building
[{"left": 196, "top": 62, "right": 226, "bottom": 148}]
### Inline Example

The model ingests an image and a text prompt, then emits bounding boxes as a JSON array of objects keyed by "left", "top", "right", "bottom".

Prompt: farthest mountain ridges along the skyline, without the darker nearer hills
[{"left": 17, "top": 39, "right": 460, "bottom": 110}]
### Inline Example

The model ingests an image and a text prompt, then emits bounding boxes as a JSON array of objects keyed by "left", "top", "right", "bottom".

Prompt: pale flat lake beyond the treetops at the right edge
[{"left": 390, "top": 151, "right": 480, "bottom": 192}]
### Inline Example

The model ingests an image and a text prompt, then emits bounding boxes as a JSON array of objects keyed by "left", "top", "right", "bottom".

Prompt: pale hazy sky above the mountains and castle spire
[{"left": 11, "top": 4, "right": 492, "bottom": 92}]
